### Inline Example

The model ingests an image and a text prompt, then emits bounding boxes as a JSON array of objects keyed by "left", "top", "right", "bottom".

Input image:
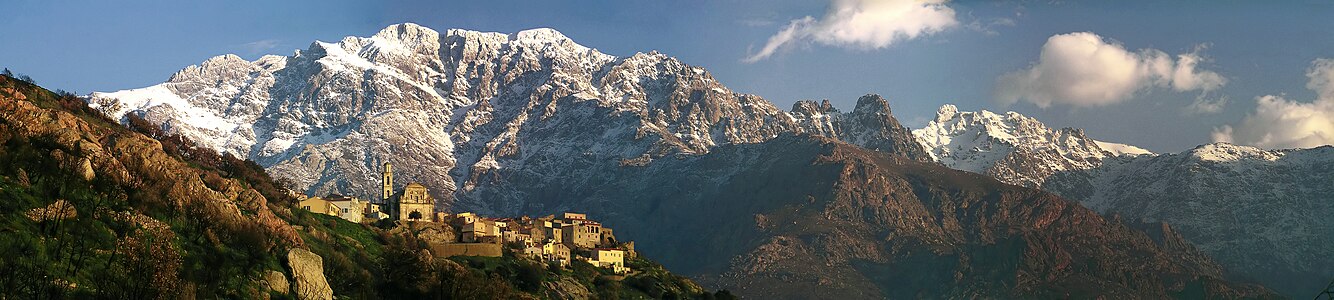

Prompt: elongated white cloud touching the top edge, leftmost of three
[{"left": 744, "top": 0, "right": 959, "bottom": 63}]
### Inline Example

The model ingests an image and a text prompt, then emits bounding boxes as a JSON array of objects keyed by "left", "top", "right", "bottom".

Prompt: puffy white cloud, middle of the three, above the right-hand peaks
[{"left": 995, "top": 32, "right": 1227, "bottom": 108}]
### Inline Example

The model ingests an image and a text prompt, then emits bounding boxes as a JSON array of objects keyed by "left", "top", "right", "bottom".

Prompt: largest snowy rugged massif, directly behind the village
[{"left": 89, "top": 24, "right": 927, "bottom": 215}]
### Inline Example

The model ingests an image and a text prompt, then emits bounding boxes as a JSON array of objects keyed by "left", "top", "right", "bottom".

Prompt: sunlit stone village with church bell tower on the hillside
[{"left": 302, "top": 163, "right": 636, "bottom": 273}]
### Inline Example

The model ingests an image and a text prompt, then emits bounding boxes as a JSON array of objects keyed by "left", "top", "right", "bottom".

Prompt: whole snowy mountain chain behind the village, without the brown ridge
[{"left": 75, "top": 24, "right": 1312, "bottom": 297}]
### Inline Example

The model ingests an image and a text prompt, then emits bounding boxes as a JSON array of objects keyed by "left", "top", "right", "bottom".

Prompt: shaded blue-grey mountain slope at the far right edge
[{"left": 1042, "top": 143, "right": 1334, "bottom": 297}]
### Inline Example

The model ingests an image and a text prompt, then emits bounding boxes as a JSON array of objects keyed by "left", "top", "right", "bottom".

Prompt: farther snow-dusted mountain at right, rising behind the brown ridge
[{"left": 914, "top": 105, "right": 1334, "bottom": 296}]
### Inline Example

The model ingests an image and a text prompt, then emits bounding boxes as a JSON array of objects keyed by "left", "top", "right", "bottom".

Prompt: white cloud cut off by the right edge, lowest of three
[{"left": 1213, "top": 59, "right": 1334, "bottom": 149}]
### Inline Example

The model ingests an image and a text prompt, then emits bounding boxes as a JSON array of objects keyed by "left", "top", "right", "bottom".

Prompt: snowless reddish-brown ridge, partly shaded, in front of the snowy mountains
[{"left": 501, "top": 135, "right": 1265, "bottom": 299}]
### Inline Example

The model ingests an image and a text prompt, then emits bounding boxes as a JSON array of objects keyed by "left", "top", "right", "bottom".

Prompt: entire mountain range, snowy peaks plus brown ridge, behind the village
[{"left": 88, "top": 24, "right": 1334, "bottom": 297}]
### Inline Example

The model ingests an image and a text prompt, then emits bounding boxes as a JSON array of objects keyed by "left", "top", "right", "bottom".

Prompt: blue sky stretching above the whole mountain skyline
[{"left": 0, "top": 0, "right": 1334, "bottom": 152}]
